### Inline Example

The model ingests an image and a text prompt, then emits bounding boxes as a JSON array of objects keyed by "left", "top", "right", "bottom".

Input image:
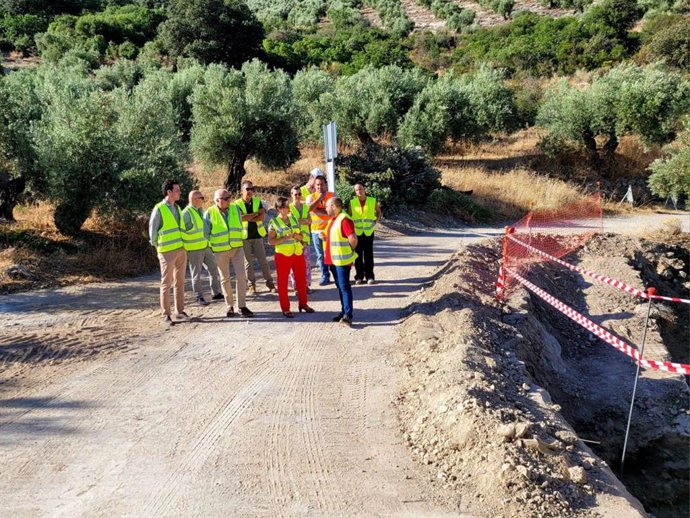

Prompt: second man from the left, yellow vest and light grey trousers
[{"left": 182, "top": 191, "right": 223, "bottom": 306}]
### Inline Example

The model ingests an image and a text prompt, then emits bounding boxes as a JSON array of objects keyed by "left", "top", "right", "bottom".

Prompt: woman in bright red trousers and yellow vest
[{"left": 268, "top": 196, "right": 314, "bottom": 318}]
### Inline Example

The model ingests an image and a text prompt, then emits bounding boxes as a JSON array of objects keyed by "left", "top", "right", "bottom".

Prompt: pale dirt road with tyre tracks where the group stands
[{"left": 0, "top": 213, "right": 684, "bottom": 517}]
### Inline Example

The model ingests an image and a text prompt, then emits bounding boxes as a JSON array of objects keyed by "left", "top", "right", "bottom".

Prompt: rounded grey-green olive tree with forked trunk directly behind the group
[{"left": 191, "top": 60, "right": 299, "bottom": 191}]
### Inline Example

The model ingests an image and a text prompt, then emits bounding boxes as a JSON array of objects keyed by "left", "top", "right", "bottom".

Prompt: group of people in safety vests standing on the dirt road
[{"left": 149, "top": 168, "right": 381, "bottom": 326}]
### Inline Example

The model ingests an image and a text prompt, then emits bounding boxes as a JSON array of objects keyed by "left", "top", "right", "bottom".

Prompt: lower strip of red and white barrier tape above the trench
[{"left": 507, "top": 270, "right": 690, "bottom": 375}]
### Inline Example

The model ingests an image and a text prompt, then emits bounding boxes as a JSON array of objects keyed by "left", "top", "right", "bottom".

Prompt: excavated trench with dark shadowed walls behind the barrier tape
[{"left": 508, "top": 240, "right": 690, "bottom": 518}]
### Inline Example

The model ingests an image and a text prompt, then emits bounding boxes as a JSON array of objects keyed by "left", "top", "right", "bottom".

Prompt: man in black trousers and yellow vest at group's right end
[{"left": 350, "top": 183, "right": 381, "bottom": 284}]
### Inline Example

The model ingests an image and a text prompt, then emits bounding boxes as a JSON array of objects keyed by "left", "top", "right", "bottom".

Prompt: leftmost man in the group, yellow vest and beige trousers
[{"left": 149, "top": 180, "right": 189, "bottom": 326}]
